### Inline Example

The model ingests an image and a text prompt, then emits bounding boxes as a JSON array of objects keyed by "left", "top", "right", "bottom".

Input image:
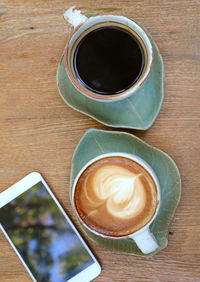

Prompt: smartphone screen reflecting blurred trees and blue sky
[{"left": 0, "top": 182, "right": 94, "bottom": 282}]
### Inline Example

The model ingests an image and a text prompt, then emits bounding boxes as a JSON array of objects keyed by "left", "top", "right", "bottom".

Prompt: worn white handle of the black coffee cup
[{"left": 64, "top": 6, "right": 88, "bottom": 28}]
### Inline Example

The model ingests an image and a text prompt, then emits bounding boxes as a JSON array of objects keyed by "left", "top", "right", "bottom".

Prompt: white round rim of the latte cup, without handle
[{"left": 72, "top": 152, "right": 161, "bottom": 239}]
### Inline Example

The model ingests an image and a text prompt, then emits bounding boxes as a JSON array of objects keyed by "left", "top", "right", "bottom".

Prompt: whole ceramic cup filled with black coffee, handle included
[{"left": 64, "top": 7, "right": 153, "bottom": 102}]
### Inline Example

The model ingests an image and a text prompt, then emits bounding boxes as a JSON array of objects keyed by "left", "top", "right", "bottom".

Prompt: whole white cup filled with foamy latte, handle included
[{"left": 72, "top": 152, "right": 161, "bottom": 254}]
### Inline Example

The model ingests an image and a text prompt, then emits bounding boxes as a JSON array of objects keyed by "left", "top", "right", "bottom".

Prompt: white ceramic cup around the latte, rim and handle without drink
[{"left": 72, "top": 152, "right": 161, "bottom": 254}]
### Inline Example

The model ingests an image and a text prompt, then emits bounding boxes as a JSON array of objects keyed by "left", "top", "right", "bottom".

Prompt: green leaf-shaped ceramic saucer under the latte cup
[{"left": 70, "top": 129, "right": 181, "bottom": 257}]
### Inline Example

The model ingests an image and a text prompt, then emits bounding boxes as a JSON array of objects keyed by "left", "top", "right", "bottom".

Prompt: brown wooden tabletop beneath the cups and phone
[{"left": 0, "top": 0, "right": 200, "bottom": 282}]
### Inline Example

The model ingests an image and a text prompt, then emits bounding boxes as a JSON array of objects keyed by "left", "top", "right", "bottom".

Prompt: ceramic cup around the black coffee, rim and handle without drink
[{"left": 64, "top": 7, "right": 153, "bottom": 102}]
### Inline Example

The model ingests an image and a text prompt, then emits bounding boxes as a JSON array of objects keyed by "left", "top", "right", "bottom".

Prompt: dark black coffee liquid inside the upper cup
[{"left": 74, "top": 26, "right": 144, "bottom": 95}]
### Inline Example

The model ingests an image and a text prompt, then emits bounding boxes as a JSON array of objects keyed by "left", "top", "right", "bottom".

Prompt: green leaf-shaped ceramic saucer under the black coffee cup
[{"left": 57, "top": 26, "right": 164, "bottom": 130}]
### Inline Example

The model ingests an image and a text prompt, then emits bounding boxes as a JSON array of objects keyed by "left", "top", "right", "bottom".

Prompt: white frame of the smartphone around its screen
[{"left": 0, "top": 172, "right": 101, "bottom": 282}]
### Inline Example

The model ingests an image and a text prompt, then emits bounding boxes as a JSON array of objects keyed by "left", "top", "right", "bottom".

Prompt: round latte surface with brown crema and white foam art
[{"left": 75, "top": 157, "right": 157, "bottom": 236}]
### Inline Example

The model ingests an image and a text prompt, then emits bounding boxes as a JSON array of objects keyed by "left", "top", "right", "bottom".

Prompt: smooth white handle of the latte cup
[{"left": 129, "top": 228, "right": 159, "bottom": 254}]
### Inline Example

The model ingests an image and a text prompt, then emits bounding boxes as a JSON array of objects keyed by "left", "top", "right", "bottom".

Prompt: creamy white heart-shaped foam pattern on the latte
[{"left": 84, "top": 165, "right": 146, "bottom": 219}]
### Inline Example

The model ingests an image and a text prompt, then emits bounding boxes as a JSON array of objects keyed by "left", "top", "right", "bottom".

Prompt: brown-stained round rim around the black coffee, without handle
[{"left": 64, "top": 15, "right": 153, "bottom": 102}]
